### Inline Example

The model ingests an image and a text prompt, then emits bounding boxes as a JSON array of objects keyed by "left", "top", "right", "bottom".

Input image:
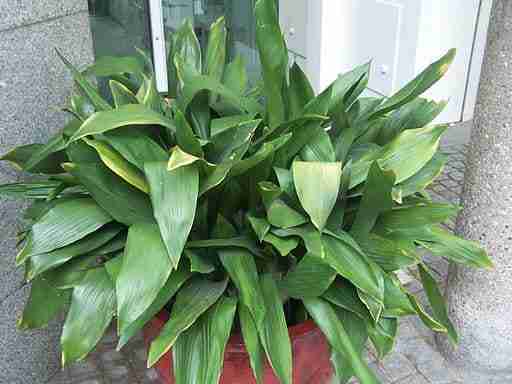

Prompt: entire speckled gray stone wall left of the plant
[{"left": 0, "top": 0, "right": 92, "bottom": 384}]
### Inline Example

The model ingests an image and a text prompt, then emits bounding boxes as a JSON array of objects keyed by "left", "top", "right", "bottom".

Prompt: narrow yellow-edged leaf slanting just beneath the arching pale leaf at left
[{"left": 83, "top": 138, "right": 149, "bottom": 193}]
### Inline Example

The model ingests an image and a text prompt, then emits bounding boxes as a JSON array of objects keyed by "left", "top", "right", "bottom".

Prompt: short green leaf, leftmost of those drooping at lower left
[{"left": 16, "top": 276, "right": 71, "bottom": 329}]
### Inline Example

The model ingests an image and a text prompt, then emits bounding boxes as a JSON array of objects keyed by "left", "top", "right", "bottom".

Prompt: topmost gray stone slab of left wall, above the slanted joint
[{"left": 0, "top": 0, "right": 87, "bottom": 31}]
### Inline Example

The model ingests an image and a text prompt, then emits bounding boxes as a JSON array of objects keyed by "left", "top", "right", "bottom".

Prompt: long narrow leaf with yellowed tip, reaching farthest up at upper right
[{"left": 372, "top": 49, "right": 457, "bottom": 118}]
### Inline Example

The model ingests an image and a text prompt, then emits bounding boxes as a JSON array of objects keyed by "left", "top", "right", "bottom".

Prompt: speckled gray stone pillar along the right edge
[{"left": 439, "top": 0, "right": 512, "bottom": 384}]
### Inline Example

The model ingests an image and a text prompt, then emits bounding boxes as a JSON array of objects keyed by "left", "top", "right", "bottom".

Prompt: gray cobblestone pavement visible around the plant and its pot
[{"left": 49, "top": 145, "right": 467, "bottom": 384}]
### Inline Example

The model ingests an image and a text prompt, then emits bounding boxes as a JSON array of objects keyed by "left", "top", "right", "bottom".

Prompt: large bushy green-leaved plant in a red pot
[{"left": 0, "top": 0, "right": 492, "bottom": 384}]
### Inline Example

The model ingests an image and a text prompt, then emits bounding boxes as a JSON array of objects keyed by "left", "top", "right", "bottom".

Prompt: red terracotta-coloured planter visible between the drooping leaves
[{"left": 144, "top": 312, "right": 333, "bottom": 384}]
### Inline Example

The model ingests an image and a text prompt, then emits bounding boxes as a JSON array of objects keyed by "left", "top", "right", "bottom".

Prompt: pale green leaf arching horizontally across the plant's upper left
[{"left": 69, "top": 104, "right": 176, "bottom": 142}]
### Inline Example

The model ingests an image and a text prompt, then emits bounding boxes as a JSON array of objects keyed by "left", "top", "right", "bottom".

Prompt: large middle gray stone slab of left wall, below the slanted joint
[{"left": 0, "top": 12, "right": 92, "bottom": 278}]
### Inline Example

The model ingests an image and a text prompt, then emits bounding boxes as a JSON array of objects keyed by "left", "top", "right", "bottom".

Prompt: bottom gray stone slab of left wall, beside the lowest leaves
[{"left": 0, "top": 286, "right": 60, "bottom": 384}]
